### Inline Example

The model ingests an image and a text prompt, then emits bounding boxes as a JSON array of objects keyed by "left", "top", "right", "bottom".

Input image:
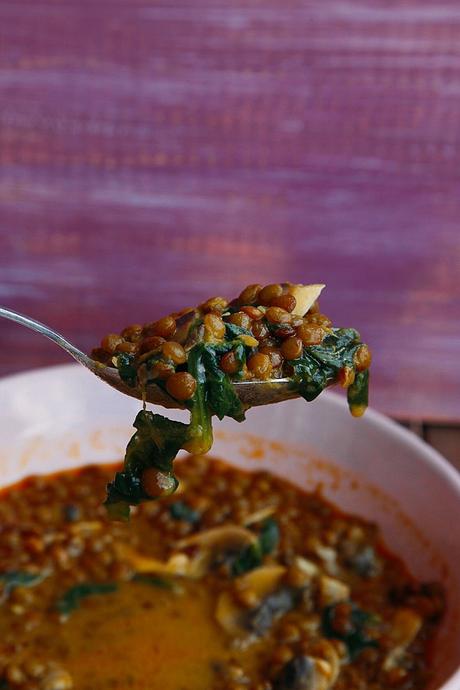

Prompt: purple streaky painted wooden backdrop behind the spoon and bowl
[{"left": 0, "top": 0, "right": 460, "bottom": 421}]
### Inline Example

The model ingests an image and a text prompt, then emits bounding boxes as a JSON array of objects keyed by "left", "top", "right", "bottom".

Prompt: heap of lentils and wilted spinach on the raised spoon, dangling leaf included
[{"left": 92, "top": 283, "right": 371, "bottom": 518}]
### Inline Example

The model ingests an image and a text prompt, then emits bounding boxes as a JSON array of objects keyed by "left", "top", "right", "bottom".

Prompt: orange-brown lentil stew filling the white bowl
[{"left": 0, "top": 456, "right": 444, "bottom": 690}]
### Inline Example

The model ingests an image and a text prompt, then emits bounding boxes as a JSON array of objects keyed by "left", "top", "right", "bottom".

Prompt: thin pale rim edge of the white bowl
[{"left": 0, "top": 363, "right": 460, "bottom": 690}]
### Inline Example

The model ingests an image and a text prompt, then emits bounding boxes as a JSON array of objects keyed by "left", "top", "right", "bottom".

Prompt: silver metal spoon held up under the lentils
[{"left": 0, "top": 307, "right": 299, "bottom": 409}]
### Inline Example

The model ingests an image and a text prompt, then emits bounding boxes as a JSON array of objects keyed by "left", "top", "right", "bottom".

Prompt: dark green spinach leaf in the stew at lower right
[{"left": 321, "top": 602, "right": 378, "bottom": 661}]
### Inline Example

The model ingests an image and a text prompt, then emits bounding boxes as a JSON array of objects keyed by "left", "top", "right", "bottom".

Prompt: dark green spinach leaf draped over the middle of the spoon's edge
[{"left": 203, "top": 346, "right": 244, "bottom": 422}]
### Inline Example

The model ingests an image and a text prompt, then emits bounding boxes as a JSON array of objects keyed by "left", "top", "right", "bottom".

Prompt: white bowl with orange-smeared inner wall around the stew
[{"left": 0, "top": 365, "right": 460, "bottom": 690}]
